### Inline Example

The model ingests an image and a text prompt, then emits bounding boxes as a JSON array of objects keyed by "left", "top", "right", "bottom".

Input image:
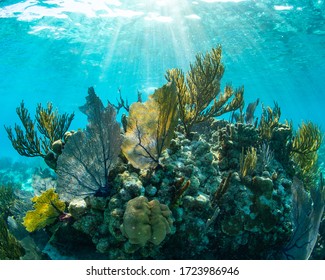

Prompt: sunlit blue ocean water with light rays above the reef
[{"left": 0, "top": 0, "right": 325, "bottom": 160}]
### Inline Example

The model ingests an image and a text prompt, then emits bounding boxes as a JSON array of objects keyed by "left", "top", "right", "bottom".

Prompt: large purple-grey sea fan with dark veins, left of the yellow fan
[{"left": 57, "top": 87, "right": 122, "bottom": 201}]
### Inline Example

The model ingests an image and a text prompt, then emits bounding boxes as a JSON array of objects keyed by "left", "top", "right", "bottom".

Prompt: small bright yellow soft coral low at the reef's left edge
[{"left": 23, "top": 189, "right": 65, "bottom": 232}]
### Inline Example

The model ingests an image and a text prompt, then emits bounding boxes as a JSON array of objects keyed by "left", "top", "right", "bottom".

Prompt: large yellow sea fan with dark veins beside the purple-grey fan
[{"left": 122, "top": 83, "right": 178, "bottom": 168}]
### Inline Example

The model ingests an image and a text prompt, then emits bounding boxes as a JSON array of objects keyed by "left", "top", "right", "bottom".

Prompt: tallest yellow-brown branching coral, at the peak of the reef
[{"left": 166, "top": 46, "right": 244, "bottom": 136}]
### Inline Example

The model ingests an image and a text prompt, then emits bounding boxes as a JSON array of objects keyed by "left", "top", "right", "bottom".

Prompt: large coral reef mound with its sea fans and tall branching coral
[{"left": 0, "top": 47, "right": 325, "bottom": 259}]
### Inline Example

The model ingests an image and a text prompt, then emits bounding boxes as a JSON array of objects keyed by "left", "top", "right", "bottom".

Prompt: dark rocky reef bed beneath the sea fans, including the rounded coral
[{"left": 1, "top": 117, "right": 322, "bottom": 259}]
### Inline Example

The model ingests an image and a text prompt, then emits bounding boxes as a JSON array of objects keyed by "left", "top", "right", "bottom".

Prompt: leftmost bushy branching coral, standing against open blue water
[{"left": 5, "top": 101, "right": 74, "bottom": 169}]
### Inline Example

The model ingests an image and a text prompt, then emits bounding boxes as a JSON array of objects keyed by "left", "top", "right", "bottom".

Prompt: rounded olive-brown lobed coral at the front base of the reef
[{"left": 121, "top": 196, "right": 172, "bottom": 246}]
